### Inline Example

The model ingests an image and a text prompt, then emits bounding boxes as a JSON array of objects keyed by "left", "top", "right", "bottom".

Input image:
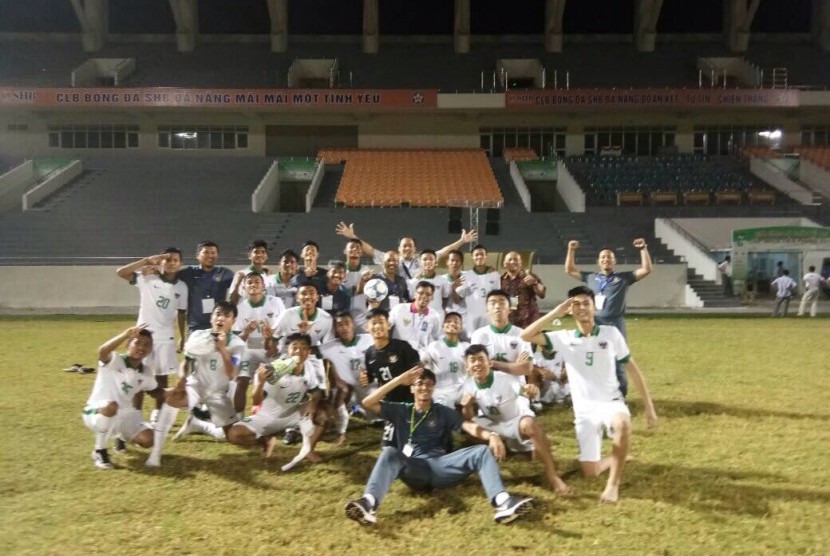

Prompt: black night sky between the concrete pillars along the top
[{"left": 0, "top": 0, "right": 811, "bottom": 35}]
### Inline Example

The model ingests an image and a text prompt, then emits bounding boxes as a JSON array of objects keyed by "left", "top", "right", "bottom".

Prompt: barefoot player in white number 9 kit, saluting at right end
[{"left": 521, "top": 286, "right": 657, "bottom": 502}]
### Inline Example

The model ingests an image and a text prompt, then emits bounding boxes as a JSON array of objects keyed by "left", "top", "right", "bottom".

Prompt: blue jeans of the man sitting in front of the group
[{"left": 365, "top": 445, "right": 504, "bottom": 506}]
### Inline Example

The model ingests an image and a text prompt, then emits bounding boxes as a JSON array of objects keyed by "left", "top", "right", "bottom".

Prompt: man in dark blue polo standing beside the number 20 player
[{"left": 176, "top": 241, "right": 233, "bottom": 333}]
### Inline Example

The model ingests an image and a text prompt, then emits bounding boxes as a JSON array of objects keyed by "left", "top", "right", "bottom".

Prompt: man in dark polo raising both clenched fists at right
[{"left": 565, "top": 238, "right": 651, "bottom": 396}]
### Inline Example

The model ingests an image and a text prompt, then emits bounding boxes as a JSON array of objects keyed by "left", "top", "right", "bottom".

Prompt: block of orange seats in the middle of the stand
[{"left": 328, "top": 149, "right": 504, "bottom": 207}]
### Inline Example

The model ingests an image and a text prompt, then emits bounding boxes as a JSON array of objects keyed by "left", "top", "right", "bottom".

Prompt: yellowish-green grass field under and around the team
[{"left": 0, "top": 316, "right": 830, "bottom": 556}]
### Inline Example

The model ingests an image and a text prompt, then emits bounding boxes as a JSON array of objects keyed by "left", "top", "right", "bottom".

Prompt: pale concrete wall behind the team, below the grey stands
[{"left": 0, "top": 265, "right": 686, "bottom": 313}]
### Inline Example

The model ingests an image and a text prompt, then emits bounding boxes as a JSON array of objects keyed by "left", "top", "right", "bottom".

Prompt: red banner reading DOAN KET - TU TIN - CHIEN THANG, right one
[{"left": 505, "top": 89, "right": 798, "bottom": 110}]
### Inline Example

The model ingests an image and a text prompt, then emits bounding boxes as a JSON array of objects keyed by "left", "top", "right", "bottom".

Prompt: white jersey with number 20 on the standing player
[{"left": 131, "top": 272, "right": 187, "bottom": 343}]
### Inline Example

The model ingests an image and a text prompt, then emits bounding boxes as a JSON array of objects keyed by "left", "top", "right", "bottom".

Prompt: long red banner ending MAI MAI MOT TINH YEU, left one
[{"left": 0, "top": 87, "right": 438, "bottom": 110}]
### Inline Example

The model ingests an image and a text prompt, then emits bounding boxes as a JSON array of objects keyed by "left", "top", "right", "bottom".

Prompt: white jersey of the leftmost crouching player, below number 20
[{"left": 86, "top": 353, "right": 158, "bottom": 410}]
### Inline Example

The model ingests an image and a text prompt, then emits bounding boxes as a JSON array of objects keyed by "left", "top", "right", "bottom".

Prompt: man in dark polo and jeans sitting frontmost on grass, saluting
[{"left": 346, "top": 366, "right": 533, "bottom": 525}]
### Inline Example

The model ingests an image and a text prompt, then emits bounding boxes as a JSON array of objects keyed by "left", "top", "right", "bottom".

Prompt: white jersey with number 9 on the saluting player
[{"left": 545, "top": 325, "right": 630, "bottom": 413}]
